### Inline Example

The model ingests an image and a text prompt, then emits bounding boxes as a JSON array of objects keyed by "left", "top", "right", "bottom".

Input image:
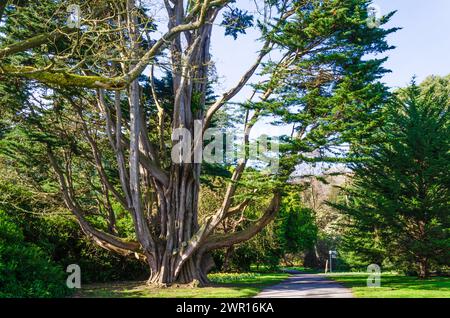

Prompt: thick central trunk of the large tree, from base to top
[{"left": 137, "top": 2, "right": 217, "bottom": 285}]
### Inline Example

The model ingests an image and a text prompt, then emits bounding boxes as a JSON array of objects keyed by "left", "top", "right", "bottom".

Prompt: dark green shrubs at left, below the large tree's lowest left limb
[{"left": 0, "top": 170, "right": 148, "bottom": 283}]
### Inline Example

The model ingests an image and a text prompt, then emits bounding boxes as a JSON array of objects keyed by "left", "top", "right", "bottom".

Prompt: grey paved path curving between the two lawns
[{"left": 256, "top": 273, "right": 353, "bottom": 298}]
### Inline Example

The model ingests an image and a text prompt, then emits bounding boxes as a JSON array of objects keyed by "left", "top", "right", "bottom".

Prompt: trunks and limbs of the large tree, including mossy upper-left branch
[{"left": 0, "top": 0, "right": 280, "bottom": 285}]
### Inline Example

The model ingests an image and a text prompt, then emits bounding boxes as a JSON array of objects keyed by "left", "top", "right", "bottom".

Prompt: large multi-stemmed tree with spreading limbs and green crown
[{"left": 0, "top": 0, "right": 394, "bottom": 284}]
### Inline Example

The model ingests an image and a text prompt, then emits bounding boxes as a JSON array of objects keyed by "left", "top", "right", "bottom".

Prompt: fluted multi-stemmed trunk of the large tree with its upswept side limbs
[{"left": 45, "top": 0, "right": 280, "bottom": 286}]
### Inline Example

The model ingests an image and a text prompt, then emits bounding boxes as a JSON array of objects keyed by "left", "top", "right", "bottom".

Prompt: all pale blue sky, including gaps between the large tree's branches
[{"left": 212, "top": 0, "right": 450, "bottom": 136}]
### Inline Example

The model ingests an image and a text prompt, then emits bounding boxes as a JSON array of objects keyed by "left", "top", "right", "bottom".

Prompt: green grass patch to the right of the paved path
[{"left": 327, "top": 273, "right": 450, "bottom": 298}]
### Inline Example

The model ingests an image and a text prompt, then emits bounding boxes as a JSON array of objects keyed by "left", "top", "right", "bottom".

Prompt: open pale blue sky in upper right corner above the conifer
[{"left": 374, "top": 0, "right": 450, "bottom": 87}]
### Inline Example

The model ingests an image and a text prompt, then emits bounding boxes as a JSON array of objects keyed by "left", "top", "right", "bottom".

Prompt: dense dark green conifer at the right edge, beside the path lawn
[{"left": 337, "top": 80, "right": 450, "bottom": 278}]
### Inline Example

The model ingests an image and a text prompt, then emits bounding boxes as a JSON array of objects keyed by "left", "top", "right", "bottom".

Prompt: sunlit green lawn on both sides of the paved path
[{"left": 74, "top": 267, "right": 450, "bottom": 298}]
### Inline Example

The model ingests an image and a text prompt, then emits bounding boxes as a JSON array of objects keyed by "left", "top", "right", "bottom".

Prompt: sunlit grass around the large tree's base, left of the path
[{"left": 75, "top": 273, "right": 289, "bottom": 298}]
